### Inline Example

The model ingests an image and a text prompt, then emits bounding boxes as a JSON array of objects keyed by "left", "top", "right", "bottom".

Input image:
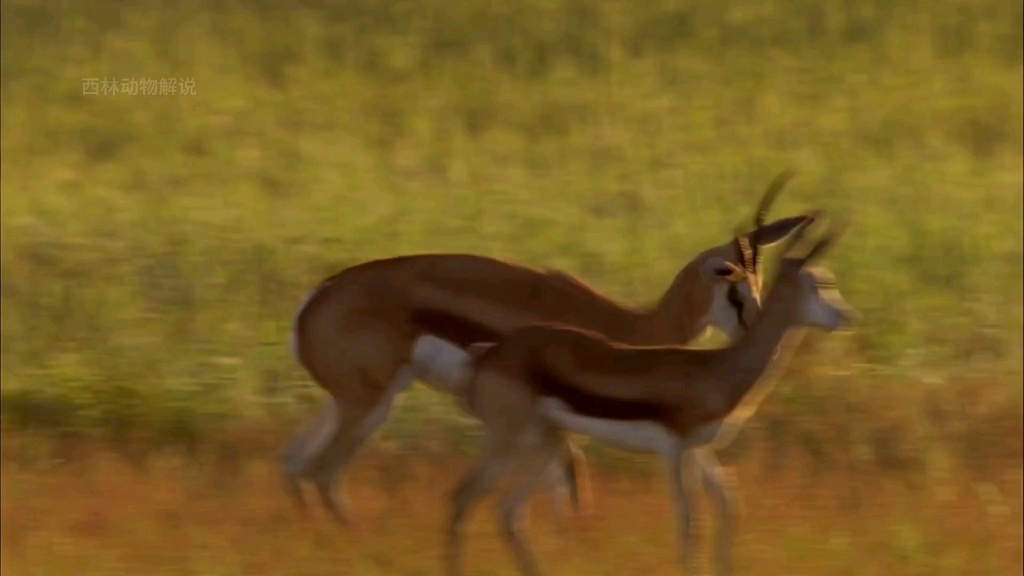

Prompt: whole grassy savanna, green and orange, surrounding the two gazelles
[{"left": 0, "top": 0, "right": 1024, "bottom": 575}]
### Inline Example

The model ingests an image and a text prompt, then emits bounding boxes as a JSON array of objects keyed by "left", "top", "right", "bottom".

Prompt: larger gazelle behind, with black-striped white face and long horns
[{"left": 283, "top": 172, "right": 806, "bottom": 522}]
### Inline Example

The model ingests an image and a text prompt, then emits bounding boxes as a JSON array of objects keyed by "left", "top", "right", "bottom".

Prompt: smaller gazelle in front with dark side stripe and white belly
[{"left": 446, "top": 213, "right": 851, "bottom": 576}]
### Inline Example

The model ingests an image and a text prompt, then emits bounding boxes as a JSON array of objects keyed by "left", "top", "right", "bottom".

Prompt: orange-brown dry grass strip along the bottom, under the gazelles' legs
[{"left": 2, "top": 435, "right": 1022, "bottom": 576}]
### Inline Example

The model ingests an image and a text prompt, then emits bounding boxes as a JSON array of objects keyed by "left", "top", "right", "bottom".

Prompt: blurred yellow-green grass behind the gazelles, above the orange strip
[{"left": 0, "top": 0, "right": 1024, "bottom": 475}]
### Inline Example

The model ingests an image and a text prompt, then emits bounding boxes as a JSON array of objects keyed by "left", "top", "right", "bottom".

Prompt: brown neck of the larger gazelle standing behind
[{"left": 634, "top": 262, "right": 712, "bottom": 344}]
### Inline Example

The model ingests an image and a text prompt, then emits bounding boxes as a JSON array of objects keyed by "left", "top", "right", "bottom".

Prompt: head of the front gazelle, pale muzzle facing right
[{"left": 765, "top": 214, "right": 856, "bottom": 332}]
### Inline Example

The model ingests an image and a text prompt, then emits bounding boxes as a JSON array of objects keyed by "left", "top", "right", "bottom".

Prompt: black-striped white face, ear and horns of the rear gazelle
[{"left": 694, "top": 170, "right": 809, "bottom": 340}]
